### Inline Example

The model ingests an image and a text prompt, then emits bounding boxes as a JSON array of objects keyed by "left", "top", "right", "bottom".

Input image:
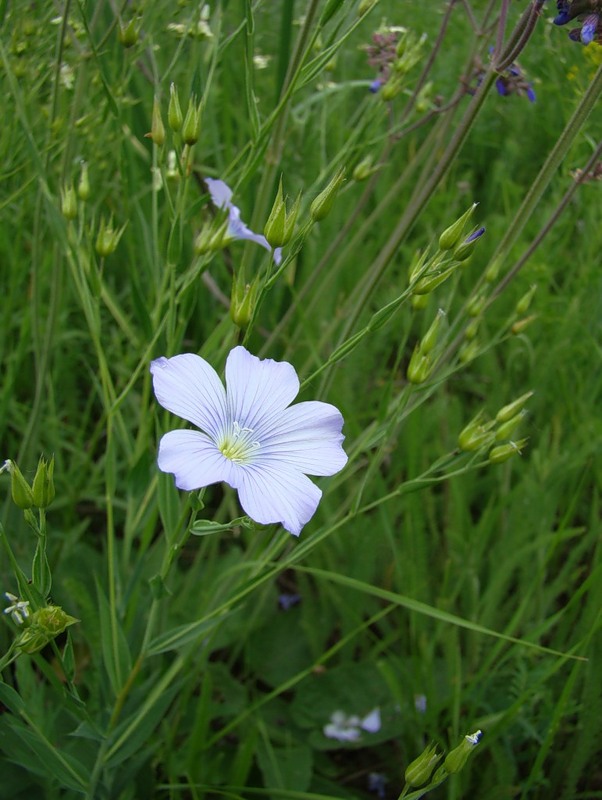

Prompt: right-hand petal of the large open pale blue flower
[{"left": 255, "top": 400, "right": 347, "bottom": 475}]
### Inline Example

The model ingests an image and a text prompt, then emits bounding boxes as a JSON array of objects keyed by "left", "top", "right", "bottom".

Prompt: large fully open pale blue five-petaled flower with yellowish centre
[{"left": 150, "top": 347, "right": 347, "bottom": 536}]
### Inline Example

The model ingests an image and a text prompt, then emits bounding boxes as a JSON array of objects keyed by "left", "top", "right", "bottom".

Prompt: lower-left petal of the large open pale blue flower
[{"left": 157, "top": 430, "right": 232, "bottom": 492}]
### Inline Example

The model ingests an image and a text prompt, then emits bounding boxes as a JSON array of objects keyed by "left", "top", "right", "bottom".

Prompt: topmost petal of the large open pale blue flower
[{"left": 226, "top": 347, "right": 299, "bottom": 434}]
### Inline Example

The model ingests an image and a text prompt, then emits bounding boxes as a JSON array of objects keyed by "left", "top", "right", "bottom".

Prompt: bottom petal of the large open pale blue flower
[{"left": 231, "top": 464, "right": 322, "bottom": 536}]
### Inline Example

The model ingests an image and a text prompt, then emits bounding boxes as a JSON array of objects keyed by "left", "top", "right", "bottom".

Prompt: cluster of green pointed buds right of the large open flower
[{"left": 458, "top": 392, "right": 533, "bottom": 464}]
